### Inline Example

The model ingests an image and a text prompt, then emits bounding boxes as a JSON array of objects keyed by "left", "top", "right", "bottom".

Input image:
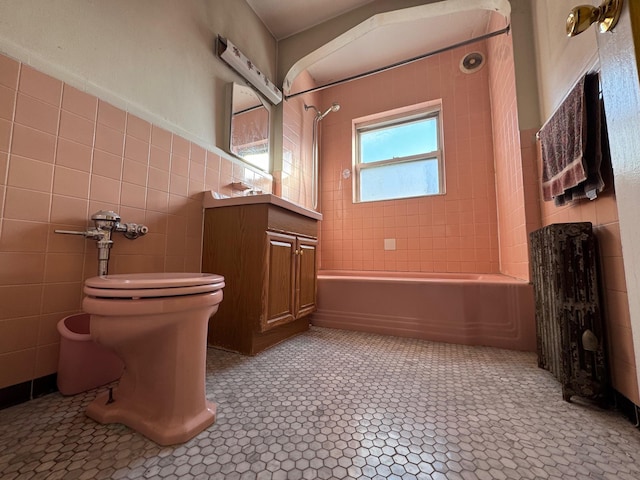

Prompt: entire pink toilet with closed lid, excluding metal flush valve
[{"left": 82, "top": 273, "right": 224, "bottom": 445}]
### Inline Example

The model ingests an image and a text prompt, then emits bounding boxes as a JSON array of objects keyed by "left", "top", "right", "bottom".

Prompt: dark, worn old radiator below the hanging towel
[{"left": 530, "top": 222, "right": 609, "bottom": 401}]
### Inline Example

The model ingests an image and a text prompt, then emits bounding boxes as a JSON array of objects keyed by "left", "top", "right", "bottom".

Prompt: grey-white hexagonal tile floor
[{"left": 0, "top": 327, "right": 640, "bottom": 480}]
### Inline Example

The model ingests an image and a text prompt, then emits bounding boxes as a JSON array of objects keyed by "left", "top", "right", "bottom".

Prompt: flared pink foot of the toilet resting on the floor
[{"left": 85, "top": 388, "right": 216, "bottom": 446}]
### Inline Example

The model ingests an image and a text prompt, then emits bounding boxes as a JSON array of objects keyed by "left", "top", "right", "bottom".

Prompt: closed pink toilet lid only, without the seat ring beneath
[{"left": 85, "top": 272, "right": 224, "bottom": 290}]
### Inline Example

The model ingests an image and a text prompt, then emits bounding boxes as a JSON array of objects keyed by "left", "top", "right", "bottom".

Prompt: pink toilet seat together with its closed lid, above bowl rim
[{"left": 84, "top": 272, "right": 224, "bottom": 298}]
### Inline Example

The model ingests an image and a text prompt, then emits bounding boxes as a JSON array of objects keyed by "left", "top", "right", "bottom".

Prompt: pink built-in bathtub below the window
[{"left": 311, "top": 270, "right": 536, "bottom": 352}]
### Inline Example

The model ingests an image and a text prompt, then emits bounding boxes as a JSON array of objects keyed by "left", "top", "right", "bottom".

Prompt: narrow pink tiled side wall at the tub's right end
[{"left": 488, "top": 16, "right": 540, "bottom": 280}]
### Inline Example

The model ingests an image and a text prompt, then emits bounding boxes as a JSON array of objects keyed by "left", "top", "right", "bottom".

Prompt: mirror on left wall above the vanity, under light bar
[{"left": 229, "top": 83, "right": 269, "bottom": 172}]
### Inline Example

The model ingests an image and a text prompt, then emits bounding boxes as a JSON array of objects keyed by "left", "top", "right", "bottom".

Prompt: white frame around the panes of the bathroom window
[{"left": 352, "top": 100, "right": 446, "bottom": 203}]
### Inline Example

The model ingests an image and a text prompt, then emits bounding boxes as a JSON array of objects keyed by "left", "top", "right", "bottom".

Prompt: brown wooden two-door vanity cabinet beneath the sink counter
[{"left": 202, "top": 203, "right": 318, "bottom": 355}]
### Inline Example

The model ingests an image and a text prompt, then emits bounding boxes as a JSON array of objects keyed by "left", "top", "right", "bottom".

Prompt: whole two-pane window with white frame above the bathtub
[{"left": 354, "top": 103, "right": 444, "bottom": 202}]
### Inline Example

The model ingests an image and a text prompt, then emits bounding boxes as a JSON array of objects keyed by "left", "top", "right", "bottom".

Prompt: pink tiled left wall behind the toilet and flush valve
[{"left": 0, "top": 55, "right": 271, "bottom": 388}]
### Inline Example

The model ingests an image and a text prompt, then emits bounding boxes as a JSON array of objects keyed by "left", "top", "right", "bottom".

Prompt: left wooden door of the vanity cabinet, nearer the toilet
[{"left": 260, "top": 232, "right": 296, "bottom": 331}]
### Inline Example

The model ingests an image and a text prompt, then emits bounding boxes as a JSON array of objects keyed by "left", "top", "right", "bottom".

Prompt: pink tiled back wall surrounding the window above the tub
[{"left": 320, "top": 44, "right": 499, "bottom": 273}]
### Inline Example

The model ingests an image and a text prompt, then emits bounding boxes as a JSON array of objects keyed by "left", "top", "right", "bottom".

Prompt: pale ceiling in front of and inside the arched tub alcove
[{"left": 247, "top": 0, "right": 510, "bottom": 94}]
